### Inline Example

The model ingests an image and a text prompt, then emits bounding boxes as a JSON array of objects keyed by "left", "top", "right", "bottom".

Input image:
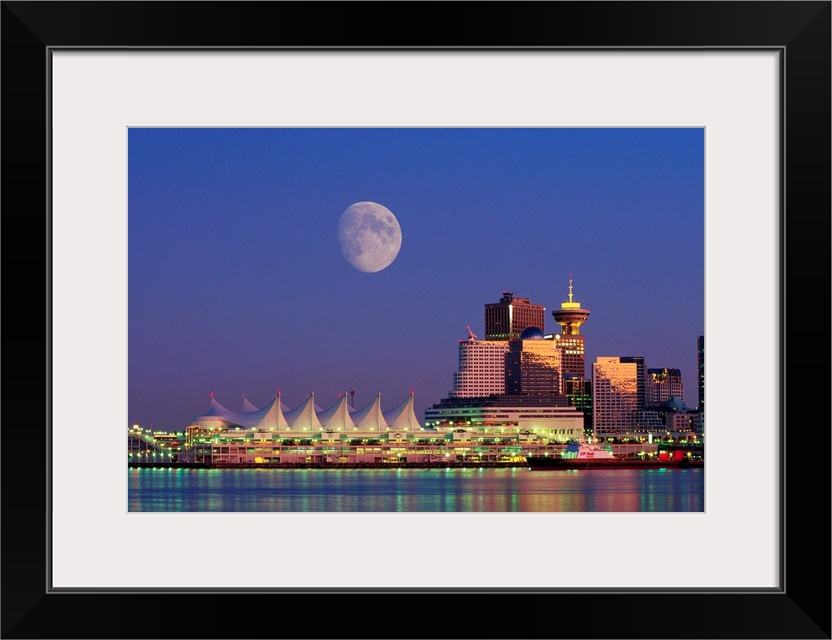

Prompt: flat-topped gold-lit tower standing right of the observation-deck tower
[{"left": 592, "top": 356, "right": 644, "bottom": 438}]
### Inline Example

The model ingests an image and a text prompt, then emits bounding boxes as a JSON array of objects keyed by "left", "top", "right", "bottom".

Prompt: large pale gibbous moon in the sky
[{"left": 338, "top": 202, "right": 402, "bottom": 273}]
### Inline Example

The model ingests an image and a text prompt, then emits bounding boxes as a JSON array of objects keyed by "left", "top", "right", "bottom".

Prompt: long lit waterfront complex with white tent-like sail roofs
[{"left": 127, "top": 393, "right": 668, "bottom": 467}]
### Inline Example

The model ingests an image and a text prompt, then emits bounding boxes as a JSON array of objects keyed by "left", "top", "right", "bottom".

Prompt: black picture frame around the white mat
[{"left": 0, "top": 1, "right": 832, "bottom": 638}]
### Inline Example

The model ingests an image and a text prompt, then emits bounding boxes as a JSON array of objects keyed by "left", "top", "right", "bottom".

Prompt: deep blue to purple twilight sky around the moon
[{"left": 128, "top": 128, "right": 705, "bottom": 431}]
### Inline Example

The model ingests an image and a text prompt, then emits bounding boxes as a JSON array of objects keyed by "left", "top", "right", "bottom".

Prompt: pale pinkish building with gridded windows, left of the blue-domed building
[{"left": 449, "top": 327, "right": 508, "bottom": 398}]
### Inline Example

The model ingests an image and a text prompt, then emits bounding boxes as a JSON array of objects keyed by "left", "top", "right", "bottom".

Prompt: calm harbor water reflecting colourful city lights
[{"left": 127, "top": 468, "right": 705, "bottom": 512}]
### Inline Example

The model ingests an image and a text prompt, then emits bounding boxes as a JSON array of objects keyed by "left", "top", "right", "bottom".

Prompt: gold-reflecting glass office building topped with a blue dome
[{"left": 505, "top": 326, "right": 561, "bottom": 396}]
